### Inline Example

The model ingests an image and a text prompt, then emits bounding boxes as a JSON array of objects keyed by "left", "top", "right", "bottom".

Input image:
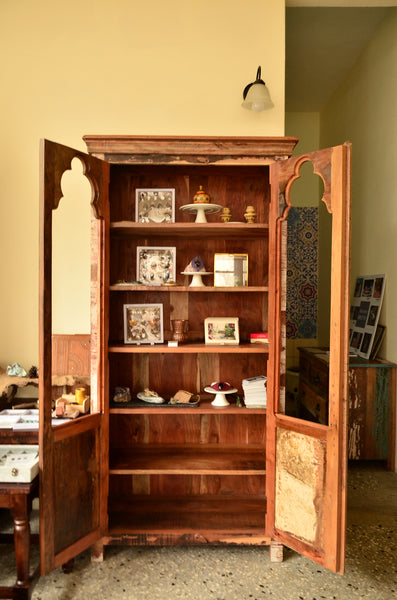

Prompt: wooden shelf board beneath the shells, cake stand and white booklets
[{"left": 109, "top": 394, "right": 266, "bottom": 417}]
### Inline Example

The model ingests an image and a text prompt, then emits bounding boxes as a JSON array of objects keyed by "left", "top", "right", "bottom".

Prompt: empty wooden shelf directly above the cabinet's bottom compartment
[{"left": 109, "top": 444, "right": 266, "bottom": 475}]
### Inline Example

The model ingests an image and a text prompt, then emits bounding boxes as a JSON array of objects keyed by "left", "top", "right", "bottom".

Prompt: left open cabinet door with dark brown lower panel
[{"left": 39, "top": 140, "right": 109, "bottom": 574}]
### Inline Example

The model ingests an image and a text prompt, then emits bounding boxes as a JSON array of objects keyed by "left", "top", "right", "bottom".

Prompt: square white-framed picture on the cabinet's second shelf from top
[{"left": 136, "top": 246, "right": 176, "bottom": 285}]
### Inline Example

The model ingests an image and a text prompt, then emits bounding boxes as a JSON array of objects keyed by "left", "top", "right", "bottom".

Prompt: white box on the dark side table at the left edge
[{"left": 0, "top": 444, "right": 39, "bottom": 483}]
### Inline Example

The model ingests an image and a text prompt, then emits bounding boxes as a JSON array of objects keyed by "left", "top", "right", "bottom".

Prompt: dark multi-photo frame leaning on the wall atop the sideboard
[{"left": 349, "top": 274, "right": 385, "bottom": 359}]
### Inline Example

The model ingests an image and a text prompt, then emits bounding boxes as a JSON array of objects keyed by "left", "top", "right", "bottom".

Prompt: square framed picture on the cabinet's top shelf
[{"left": 135, "top": 188, "right": 175, "bottom": 223}]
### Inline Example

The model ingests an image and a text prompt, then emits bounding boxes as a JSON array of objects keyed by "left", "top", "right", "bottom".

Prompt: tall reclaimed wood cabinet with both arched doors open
[{"left": 40, "top": 135, "right": 350, "bottom": 573}]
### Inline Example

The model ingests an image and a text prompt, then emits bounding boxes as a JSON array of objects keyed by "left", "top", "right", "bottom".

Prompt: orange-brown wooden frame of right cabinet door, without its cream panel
[{"left": 266, "top": 143, "right": 351, "bottom": 573}]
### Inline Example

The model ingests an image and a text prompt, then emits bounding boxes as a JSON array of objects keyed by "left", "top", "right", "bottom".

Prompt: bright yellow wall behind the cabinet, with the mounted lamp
[{"left": 0, "top": 0, "right": 285, "bottom": 368}]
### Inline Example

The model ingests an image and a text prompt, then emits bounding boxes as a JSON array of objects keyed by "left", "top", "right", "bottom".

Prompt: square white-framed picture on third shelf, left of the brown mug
[{"left": 123, "top": 304, "right": 164, "bottom": 344}]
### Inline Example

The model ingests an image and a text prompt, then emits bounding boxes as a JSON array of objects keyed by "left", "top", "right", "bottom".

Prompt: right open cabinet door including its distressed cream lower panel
[{"left": 266, "top": 143, "right": 350, "bottom": 573}]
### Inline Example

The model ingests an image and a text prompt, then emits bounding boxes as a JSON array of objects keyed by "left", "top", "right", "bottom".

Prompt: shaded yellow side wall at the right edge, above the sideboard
[{"left": 320, "top": 9, "right": 397, "bottom": 468}]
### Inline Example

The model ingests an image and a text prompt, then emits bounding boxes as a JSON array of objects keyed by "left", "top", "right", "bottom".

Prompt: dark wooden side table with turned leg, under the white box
[{"left": 0, "top": 476, "right": 39, "bottom": 600}]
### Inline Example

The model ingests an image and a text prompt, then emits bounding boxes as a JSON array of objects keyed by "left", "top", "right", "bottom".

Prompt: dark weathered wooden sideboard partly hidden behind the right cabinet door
[{"left": 299, "top": 348, "right": 397, "bottom": 471}]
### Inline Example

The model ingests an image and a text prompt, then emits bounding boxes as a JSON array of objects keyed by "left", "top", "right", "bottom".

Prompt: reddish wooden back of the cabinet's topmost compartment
[{"left": 110, "top": 165, "right": 269, "bottom": 223}]
